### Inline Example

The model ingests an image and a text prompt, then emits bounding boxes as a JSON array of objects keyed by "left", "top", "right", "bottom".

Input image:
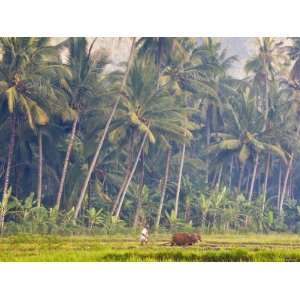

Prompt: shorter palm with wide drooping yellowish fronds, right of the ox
[{"left": 208, "top": 92, "right": 287, "bottom": 200}]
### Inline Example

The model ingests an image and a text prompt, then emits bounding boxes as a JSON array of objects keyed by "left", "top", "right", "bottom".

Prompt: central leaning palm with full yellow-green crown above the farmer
[{"left": 111, "top": 60, "right": 192, "bottom": 218}]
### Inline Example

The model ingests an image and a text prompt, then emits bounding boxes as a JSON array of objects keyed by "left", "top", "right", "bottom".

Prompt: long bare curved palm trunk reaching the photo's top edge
[{"left": 74, "top": 38, "right": 136, "bottom": 220}]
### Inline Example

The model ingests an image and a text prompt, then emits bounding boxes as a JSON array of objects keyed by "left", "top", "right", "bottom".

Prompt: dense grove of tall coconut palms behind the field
[{"left": 0, "top": 37, "right": 300, "bottom": 233}]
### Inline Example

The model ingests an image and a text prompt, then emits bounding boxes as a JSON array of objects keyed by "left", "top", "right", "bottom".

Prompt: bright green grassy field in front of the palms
[{"left": 0, "top": 234, "right": 300, "bottom": 262}]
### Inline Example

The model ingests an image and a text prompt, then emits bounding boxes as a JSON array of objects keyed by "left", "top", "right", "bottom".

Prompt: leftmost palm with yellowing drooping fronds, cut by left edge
[{"left": 0, "top": 38, "right": 60, "bottom": 202}]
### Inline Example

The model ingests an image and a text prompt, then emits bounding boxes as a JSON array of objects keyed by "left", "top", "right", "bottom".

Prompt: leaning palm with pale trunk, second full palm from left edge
[{"left": 55, "top": 38, "right": 113, "bottom": 209}]
